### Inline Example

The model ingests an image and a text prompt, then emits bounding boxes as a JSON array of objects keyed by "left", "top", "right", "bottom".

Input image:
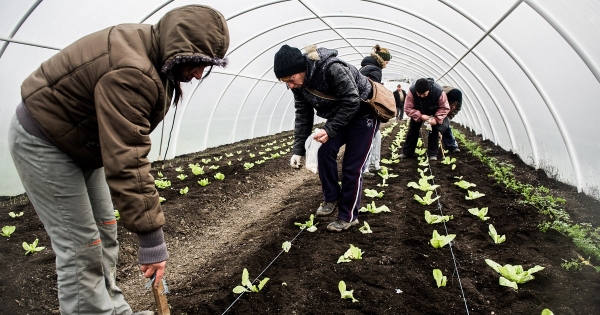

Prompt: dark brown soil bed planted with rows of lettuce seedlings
[{"left": 0, "top": 122, "right": 600, "bottom": 315}]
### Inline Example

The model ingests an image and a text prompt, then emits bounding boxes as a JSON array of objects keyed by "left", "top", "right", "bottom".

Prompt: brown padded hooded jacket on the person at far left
[{"left": 21, "top": 5, "right": 229, "bottom": 234}]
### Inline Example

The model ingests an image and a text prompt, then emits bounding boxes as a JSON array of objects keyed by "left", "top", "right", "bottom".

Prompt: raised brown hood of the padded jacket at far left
[{"left": 154, "top": 5, "right": 229, "bottom": 74}]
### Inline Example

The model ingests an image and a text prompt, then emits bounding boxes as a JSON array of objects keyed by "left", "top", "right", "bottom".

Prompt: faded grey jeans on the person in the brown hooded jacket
[{"left": 8, "top": 115, "right": 132, "bottom": 315}]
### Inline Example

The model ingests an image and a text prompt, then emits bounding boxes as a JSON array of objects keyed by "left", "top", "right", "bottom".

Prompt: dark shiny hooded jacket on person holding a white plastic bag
[{"left": 292, "top": 46, "right": 374, "bottom": 155}]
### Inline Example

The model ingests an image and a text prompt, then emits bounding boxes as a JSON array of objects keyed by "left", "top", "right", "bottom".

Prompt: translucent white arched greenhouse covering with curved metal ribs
[{"left": 0, "top": 0, "right": 600, "bottom": 199}]
